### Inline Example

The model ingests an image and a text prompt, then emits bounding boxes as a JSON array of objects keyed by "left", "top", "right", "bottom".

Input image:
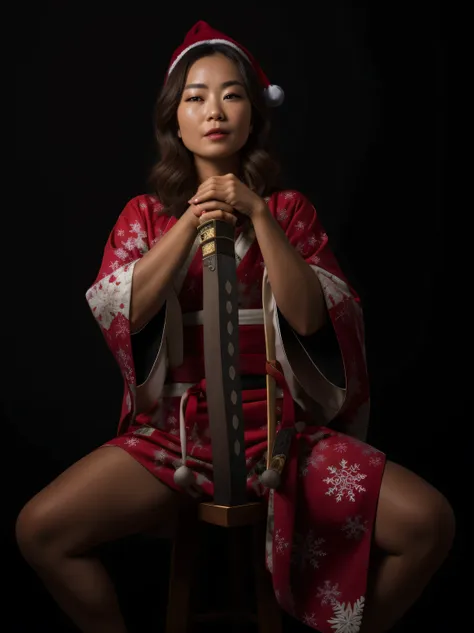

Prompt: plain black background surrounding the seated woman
[{"left": 10, "top": 0, "right": 466, "bottom": 633}]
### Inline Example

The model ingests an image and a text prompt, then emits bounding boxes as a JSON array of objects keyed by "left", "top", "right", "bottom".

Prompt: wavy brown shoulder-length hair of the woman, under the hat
[{"left": 149, "top": 44, "right": 280, "bottom": 217}]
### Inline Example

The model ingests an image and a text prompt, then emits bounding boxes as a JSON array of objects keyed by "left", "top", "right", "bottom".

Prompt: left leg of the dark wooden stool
[{"left": 165, "top": 516, "right": 199, "bottom": 633}]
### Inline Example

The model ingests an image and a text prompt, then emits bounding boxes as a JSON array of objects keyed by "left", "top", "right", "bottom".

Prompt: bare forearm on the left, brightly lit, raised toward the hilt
[{"left": 130, "top": 212, "right": 198, "bottom": 332}]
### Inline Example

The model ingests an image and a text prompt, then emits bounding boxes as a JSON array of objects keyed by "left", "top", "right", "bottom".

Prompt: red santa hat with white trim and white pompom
[{"left": 167, "top": 20, "right": 285, "bottom": 106}]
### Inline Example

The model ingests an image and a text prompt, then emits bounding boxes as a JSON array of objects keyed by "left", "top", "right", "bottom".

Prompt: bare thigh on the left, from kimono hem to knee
[{"left": 17, "top": 447, "right": 191, "bottom": 554}]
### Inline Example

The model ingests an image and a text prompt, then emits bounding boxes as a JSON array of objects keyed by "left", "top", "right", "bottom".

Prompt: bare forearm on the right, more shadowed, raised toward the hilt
[{"left": 252, "top": 205, "right": 327, "bottom": 336}]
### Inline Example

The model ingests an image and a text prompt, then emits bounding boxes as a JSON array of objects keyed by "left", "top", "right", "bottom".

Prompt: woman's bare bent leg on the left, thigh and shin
[{"left": 16, "top": 447, "right": 192, "bottom": 633}]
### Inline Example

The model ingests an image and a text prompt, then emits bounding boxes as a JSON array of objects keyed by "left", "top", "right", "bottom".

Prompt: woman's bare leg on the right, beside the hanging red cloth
[{"left": 361, "top": 462, "right": 455, "bottom": 633}]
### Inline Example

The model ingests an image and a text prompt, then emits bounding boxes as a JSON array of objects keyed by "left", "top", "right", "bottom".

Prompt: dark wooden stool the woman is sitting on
[{"left": 166, "top": 502, "right": 282, "bottom": 633}]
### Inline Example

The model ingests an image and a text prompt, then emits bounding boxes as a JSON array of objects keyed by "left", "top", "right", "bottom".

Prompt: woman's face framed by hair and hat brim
[{"left": 177, "top": 53, "right": 252, "bottom": 162}]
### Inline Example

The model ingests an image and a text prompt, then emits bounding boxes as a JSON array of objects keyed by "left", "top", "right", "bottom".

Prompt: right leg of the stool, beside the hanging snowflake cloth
[{"left": 253, "top": 522, "right": 283, "bottom": 633}]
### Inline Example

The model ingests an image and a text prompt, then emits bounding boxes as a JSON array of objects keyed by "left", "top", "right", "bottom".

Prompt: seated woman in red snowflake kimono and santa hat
[{"left": 17, "top": 22, "right": 454, "bottom": 633}]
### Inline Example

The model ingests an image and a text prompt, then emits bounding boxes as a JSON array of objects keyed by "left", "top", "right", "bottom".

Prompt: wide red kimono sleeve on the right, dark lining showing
[{"left": 263, "top": 191, "right": 369, "bottom": 440}]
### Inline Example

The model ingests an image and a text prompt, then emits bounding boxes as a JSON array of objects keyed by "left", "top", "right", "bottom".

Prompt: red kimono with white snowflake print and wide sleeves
[{"left": 87, "top": 191, "right": 385, "bottom": 633}]
